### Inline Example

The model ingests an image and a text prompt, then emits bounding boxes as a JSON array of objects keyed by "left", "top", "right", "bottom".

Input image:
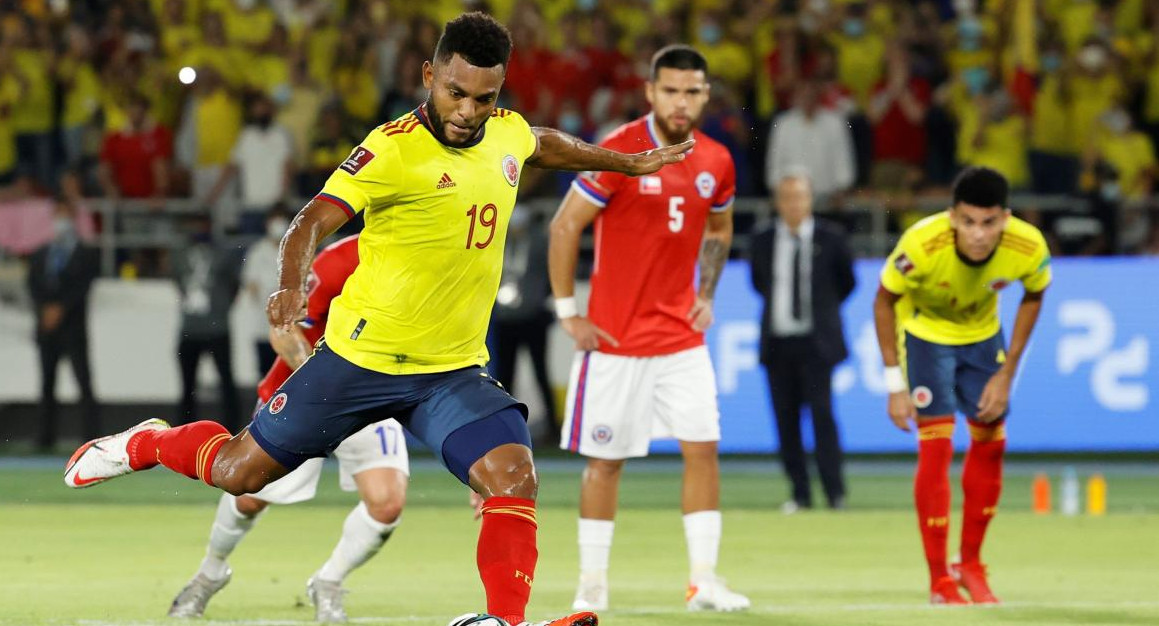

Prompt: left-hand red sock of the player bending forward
[{"left": 913, "top": 415, "right": 954, "bottom": 584}]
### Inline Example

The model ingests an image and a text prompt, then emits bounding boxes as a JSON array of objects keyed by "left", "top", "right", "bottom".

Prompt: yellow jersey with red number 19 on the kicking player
[{"left": 318, "top": 109, "right": 537, "bottom": 374}]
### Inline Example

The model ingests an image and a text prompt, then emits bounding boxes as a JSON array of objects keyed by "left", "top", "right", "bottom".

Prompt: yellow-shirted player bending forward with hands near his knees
[{"left": 874, "top": 167, "right": 1050, "bottom": 604}]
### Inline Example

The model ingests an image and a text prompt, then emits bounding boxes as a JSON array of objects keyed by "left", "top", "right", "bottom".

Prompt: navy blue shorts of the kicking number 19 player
[{"left": 249, "top": 342, "right": 530, "bottom": 480}]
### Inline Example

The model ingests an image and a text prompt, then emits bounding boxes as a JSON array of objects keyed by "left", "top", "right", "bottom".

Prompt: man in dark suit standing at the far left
[{"left": 28, "top": 199, "right": 101, "bottom": 451}]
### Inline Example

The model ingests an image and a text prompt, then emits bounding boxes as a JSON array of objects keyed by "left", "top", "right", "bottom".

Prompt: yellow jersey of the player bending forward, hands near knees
[{"left": 881, "top": 211, "right": 1050, "bottom": 345}]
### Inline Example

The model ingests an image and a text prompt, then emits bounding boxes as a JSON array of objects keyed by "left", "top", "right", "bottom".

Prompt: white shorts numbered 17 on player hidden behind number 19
[{"left": 253, "top": 420, "right": 410, "bottom": 504}]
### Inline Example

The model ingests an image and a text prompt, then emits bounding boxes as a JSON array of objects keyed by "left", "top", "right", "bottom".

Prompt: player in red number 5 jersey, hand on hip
[{"left": 549, "top": 45, "right": 749, "bottom": 611}]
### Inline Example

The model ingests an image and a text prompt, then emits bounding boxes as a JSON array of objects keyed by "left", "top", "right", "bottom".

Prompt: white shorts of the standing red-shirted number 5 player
[{"left": 560, "top": 345, "right": 721, "bottom": 460}]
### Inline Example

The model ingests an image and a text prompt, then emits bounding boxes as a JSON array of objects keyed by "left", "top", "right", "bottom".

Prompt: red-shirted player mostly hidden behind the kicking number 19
[{"left": 169, "top": 235, "right": 409, "bottom": 623}]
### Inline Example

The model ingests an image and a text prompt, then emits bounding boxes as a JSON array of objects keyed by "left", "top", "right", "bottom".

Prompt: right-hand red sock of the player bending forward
[{"left": 962, "top": 421, "right": 1006, "bottom": 563}]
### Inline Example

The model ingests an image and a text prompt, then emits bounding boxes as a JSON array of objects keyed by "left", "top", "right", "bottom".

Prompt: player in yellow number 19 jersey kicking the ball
[{"left": 65, "top": 13, "right": 692, "bottom": 626}]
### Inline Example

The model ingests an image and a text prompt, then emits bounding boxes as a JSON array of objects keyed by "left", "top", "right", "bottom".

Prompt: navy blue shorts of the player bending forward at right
[{"left": 905, "top": 332, "right": 1006, "bottom": 420}]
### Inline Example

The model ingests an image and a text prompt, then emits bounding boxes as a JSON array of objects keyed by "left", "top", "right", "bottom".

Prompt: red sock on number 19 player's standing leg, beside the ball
[{"left": 476, "top": 497, "right": 539, "bottom": 625}]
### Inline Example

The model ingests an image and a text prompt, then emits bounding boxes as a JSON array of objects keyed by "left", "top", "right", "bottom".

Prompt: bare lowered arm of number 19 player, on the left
[{"left": 265, "top": 199, "right": 350, "bottom": 330}]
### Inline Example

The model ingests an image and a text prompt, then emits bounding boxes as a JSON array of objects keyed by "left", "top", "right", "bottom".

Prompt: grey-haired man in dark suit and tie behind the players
[{"left": 750, "top": 172, "right": 854, "bottom": 514}]
